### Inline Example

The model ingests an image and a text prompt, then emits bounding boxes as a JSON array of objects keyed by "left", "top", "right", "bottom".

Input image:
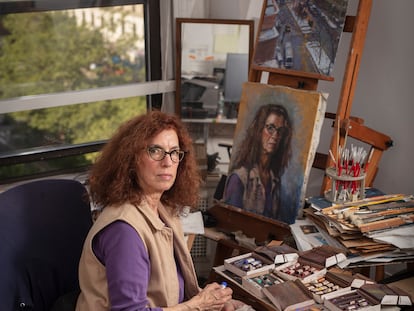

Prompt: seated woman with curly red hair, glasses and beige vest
[{"left": 76, "top": 112, "right": 242, "bottom": 311}]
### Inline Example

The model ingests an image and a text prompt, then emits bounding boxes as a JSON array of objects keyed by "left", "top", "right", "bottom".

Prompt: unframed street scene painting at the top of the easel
[{"left": 252, "top": 0, "right": 348, "bottom": 80}]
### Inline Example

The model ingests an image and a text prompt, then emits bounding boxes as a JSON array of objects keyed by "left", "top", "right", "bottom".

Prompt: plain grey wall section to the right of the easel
[{"left": 346, "top": 0, "right": 414, "bottom": 193}]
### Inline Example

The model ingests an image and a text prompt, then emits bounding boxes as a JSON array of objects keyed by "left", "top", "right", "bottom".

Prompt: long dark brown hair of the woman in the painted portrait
[{"left": 230, "top": 104, "right": 292, "bottom": 177}]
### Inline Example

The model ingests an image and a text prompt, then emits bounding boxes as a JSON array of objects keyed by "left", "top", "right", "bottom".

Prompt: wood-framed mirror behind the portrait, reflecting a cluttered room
[{"left": 175, "top": 18, "right": 254, "bottom": 119}]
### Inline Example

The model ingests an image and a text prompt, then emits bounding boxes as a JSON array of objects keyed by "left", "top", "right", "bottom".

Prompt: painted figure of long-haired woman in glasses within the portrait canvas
[{"left": 223, "top": 104, "right": 292, "bottom": 220}]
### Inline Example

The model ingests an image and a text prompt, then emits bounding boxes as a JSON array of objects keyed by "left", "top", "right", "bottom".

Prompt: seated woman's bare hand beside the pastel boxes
[{"left": 184, "top": 283, "right": 233, "bottom": 311}]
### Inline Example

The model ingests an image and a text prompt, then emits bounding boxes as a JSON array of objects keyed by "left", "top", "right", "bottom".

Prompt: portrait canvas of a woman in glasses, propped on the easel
[{"left": 223, "top": 82, "right": 326, "bottom": 224}]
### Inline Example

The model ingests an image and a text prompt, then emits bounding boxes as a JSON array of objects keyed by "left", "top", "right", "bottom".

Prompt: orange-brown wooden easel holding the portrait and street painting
[{"left": 209, "top": 0, "right": 392, "bottom": 298}]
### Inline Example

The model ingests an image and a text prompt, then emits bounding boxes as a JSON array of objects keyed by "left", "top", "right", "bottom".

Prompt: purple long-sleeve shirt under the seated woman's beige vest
[{"left": 92, "top": 221, "right": 184, "bottom": 311}]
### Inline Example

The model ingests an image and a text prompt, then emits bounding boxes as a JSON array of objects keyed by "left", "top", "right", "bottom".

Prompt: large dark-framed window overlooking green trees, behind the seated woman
[{"left": 0, "top": 0, "right": 163, "bottom": 183}]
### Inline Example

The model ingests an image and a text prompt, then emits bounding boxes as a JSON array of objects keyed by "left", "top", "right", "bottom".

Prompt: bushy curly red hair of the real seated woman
[{"left": 89, "top": 111, "right": 201, "bottom": 213}]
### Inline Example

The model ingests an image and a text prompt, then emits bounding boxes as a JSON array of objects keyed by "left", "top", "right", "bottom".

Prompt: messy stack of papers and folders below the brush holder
[{"left": 298, "top": 194, "right": 414, "bottom": 265}]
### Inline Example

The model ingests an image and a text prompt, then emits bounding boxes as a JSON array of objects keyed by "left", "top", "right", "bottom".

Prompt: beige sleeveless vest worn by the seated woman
[{"left": 76, "top": 203, "right": 199, "bottom": 311}]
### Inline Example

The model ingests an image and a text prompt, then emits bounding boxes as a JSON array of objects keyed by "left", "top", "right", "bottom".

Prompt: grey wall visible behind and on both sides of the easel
[{"left": 199, "top": 0, "right": 414, "bottom": 195}]
